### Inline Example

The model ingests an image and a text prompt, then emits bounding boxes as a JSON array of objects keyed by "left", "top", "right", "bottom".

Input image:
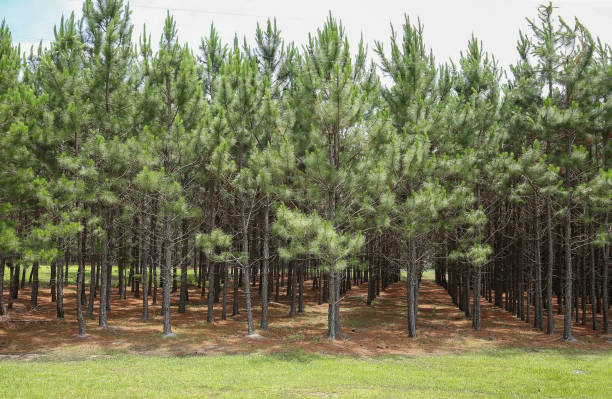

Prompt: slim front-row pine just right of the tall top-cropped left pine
[{"left": 137, "top": 13, "right": 203, "bottom": 336}]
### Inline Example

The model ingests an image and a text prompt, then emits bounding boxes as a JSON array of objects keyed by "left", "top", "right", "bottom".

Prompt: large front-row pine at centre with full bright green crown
[{"left": 276, "top": 15, "right": 378, "bottom": 339}]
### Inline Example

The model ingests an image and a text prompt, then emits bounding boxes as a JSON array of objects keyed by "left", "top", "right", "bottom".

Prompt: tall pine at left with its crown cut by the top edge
[{"left": 81, "top": 0, "right": 133, "bottom": 328}]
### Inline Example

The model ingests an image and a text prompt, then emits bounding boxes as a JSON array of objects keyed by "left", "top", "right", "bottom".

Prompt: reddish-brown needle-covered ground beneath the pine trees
[{"left": 0, "top": 280, "right": 612, "bottom": 356}]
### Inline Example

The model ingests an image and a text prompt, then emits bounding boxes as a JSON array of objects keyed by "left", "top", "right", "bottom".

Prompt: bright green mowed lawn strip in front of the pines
[{"left": 0, "top": 350, "right": 612, "bottom": 399}]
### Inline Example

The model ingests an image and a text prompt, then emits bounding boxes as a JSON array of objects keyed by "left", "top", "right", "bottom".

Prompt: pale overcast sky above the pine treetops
[{"left": 0, "top": 0, "right": 612, "bottom": 67}]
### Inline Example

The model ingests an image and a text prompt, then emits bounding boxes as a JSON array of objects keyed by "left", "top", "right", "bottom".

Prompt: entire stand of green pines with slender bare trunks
[{"left": 0, "top": 0, "right": 612, "bottom": 340}]
